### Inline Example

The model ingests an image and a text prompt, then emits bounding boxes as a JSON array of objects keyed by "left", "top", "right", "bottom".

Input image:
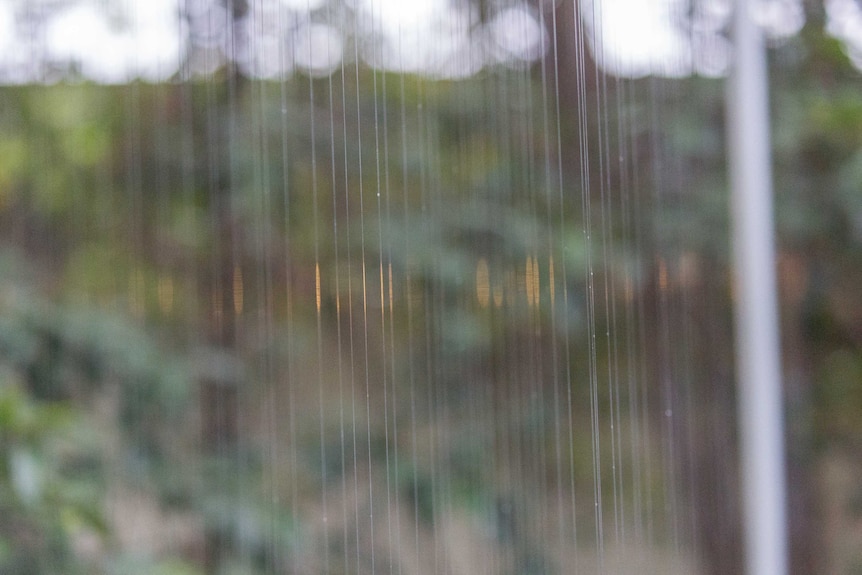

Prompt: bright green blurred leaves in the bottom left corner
[{"left": 0, "top": 378, "right": 107, "bottom": 574}]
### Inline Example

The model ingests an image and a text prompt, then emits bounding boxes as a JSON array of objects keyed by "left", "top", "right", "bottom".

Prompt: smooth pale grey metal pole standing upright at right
[{"left": 727, "top": 0, "right": 787, "bottom": 575}]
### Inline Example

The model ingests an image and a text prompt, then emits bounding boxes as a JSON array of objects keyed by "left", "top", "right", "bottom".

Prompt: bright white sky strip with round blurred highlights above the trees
[{"left": 0, "top": 0, "right": 862, "bottom": 84}]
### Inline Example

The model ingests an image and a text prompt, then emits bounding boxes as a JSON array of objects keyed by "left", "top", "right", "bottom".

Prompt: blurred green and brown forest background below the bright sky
[{"left": 0, "top": 0, "right": 862, "bottom": 575}]
